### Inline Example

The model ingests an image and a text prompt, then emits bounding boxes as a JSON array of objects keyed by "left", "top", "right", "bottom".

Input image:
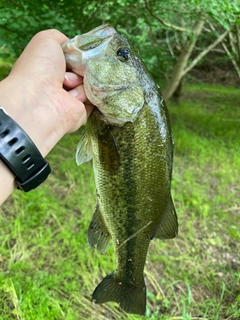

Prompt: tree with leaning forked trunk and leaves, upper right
[{"left": 144, "top": 0, "right": 240, "bottom": 100}]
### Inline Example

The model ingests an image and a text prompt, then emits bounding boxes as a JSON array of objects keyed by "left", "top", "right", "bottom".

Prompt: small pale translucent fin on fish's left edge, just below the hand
[{"left": 76, "top": 131, "right": 92, "bottom": 166}]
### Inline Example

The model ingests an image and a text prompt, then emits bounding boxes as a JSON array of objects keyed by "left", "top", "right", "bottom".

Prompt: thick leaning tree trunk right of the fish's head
[{"left": 163, "top": 20, "right": 204, "bottom": 100}]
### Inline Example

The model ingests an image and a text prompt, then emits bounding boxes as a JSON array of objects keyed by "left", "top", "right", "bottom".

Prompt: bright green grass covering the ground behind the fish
[{"left": 0, "top": 85, "right": 240, "bottom": 320}]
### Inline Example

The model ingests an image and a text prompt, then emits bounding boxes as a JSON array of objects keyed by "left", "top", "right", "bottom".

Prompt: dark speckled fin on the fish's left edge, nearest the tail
[{"left": 88, "top": 204, "right": 111, "bottom": 253}]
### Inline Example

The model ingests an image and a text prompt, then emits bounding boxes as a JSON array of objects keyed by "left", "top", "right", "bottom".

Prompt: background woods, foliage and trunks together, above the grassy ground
[{"left": 0, "top": 0, "right": 240, "bottom": 100}]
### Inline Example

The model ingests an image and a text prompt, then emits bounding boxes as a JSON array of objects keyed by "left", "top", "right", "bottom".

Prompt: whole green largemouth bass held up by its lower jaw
[{"left": 63, "top": 25, "right": 178, "bottom": 315}]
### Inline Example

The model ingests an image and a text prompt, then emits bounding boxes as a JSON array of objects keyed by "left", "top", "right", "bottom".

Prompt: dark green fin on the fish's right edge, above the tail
[{"left": 154, "top": 196, "right": 178, "bottom": 239}]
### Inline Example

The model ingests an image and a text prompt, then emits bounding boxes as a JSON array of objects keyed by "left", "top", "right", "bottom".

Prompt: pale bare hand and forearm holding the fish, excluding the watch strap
[{"left": 0, "top": 30, "right": 93, "bottom": 204}]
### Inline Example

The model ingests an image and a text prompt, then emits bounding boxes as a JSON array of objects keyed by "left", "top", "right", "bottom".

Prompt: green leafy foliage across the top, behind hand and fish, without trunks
[{"left": 0, "top": 0, "right": 240, "bottom": 82}]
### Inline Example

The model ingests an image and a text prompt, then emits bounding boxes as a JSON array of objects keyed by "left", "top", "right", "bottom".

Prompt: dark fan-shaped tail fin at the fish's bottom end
[{"left": 92, "top": 273, "right": 146, "bottom": 315}]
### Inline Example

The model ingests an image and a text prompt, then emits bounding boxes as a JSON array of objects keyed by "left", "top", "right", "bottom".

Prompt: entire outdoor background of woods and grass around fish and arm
[{"left": 0, "top": 0, "right": 240, "bottom": 320}]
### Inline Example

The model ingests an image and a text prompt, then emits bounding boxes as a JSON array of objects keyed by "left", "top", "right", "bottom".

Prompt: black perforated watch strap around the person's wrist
[{"left": 0, "top": 107, "right": 51, "bottom": 192}]
